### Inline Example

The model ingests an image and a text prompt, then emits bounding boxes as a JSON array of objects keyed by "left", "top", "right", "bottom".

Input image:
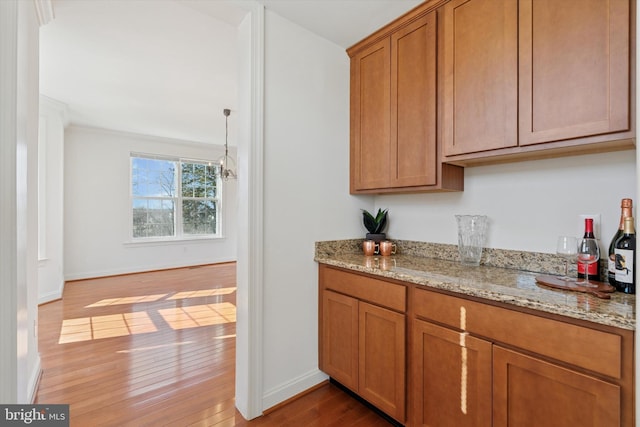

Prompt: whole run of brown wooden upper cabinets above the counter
[{"left": 347, "top": 0, "right": 636, "bottom": 188}]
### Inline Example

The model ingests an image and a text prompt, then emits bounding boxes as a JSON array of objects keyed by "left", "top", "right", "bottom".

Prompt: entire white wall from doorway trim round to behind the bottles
[{"left": 262, "top": 5, "right": 637, "bottom": 409}]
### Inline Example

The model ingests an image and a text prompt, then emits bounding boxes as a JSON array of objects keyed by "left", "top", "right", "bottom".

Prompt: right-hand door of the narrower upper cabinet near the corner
[{"left": 390, "top": 12, "right": 438, "bottom": 187}]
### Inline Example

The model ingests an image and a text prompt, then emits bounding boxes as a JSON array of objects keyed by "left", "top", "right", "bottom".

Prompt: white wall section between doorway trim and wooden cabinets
[{"left": 263, "top": 10, "right": 372, "bottom": 409}]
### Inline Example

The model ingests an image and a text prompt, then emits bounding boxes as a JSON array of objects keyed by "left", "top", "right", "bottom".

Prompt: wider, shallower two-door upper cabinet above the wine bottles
[{"left": 442, "top": 0, "right": 635, "bottom": 165}]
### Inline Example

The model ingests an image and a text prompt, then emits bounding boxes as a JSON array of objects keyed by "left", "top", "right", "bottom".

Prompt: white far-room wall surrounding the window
[{"left": 64, "top": 125, "right": 236, "bottom": 280}]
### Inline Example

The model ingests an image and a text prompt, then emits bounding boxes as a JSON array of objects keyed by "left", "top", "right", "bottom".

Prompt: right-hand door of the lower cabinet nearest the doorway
[{"left": 358, "top": 302, "right": 406, "bottom": 422}]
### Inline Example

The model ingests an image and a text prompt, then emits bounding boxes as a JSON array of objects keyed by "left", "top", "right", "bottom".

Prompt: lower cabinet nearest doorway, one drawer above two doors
[{"left": 320, "top": 269, "right": 406, "bottom": 422}]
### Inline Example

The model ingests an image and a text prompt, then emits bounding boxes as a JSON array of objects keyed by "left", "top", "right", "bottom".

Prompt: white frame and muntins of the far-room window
[{"left": 127, "top": 152, "right": 224, "bottom": 245}]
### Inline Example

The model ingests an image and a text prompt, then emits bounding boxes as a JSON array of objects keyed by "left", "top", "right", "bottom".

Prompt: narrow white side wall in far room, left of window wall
[{"left": 38, "top": 96, "right": 67, "bottom": 304}]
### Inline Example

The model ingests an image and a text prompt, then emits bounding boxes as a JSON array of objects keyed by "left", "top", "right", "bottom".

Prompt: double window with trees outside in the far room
[{"left": 131, "top": 154, "right": 221, "bottom": 239}]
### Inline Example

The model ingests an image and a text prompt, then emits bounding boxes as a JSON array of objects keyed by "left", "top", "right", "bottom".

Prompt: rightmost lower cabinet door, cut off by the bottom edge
[{"left": 493, "top": 346, "right": 620, "bottom": 427}]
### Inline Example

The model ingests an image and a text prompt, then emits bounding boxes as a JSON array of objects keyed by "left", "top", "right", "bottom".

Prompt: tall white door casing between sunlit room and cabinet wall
[{"left": 235, "top": 2, "right": 265, "bottom": 419}]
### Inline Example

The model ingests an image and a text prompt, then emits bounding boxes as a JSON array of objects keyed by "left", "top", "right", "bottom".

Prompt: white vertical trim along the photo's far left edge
[{"left": 0, "top": 0, "right": 18, "bottom": 403}]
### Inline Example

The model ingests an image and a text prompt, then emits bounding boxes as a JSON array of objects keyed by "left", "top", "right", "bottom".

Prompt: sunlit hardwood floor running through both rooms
[{"left": 35, "top": 263, "right": 390, "bottom": 427}]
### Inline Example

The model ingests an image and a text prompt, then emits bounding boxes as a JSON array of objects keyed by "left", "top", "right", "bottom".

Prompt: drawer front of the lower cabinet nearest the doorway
[{"left": 320, "top": 266, "right": 407, "bottom": 312}]
